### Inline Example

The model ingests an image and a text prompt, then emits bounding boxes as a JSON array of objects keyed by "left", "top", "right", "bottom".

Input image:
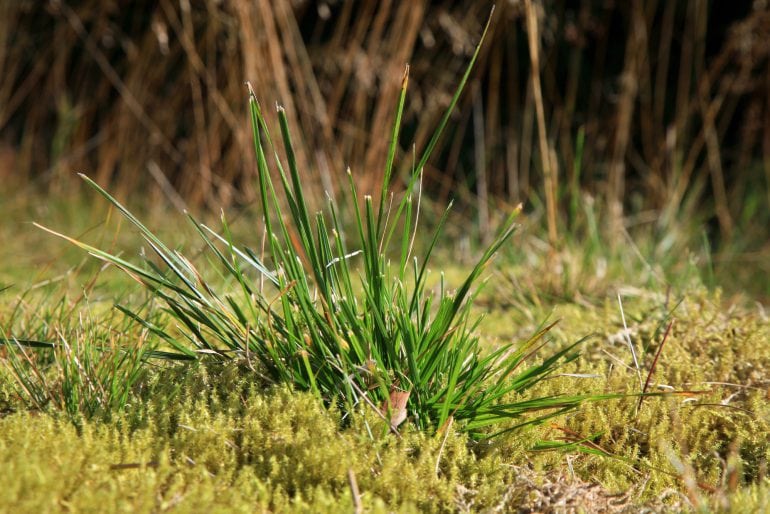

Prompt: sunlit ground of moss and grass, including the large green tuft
[{"left": 0, "top": 7, "right": 770, "bottom": 512}]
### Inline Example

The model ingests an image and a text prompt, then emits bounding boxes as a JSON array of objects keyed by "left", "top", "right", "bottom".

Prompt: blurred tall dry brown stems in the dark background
[{"left": 0, "top": 0, "right": 770, "bottom": 241}]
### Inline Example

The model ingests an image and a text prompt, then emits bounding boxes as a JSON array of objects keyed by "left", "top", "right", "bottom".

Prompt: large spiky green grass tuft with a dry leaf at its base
[{"left": 33, "top": 18, "right": 600, "bottom": 437}]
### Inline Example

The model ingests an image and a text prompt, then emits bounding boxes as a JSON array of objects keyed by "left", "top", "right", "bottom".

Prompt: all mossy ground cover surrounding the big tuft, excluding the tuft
[{"left": 0, "top": 193, "right": 770, "bottom": 512}]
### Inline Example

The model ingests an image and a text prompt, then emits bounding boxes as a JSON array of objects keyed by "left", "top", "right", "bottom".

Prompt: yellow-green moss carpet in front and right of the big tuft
[{"left": 0, "top": 247, "right": 770, "bottom": 512}]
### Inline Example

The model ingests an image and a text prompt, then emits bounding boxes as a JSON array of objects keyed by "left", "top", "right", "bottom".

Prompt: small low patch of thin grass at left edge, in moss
[{"left": 0, "top": 284, "right": 154, "bottom": 424}]
